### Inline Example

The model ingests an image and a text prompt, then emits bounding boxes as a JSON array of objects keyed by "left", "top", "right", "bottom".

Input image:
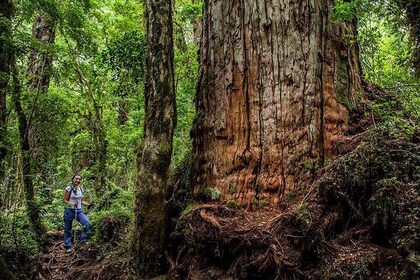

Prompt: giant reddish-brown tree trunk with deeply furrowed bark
[{"left": 192, "top": 0, "right": 360, "bottom": 205}]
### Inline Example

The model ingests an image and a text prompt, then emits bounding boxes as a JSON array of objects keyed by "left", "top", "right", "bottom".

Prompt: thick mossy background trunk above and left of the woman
[{"left": 27, "top": 11, "right": 55, "bottom": 167}]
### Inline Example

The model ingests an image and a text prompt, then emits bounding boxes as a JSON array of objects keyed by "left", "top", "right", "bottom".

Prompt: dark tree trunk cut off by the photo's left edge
[{"left": 0, "top": 0, "right": 13, "bottom": 165}]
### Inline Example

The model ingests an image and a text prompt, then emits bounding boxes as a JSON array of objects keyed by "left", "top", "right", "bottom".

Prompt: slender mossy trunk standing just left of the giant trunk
[{"left": 133, "top": 0, "right": 176, "bottom": 277}]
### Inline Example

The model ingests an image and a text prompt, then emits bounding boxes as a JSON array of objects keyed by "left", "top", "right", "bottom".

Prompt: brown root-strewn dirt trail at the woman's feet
[{"left": 39, "top": 231, "right": 104, "bottom": 280}]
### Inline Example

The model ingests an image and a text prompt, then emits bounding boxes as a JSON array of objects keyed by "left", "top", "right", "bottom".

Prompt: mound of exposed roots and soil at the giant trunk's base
[{"left": 169, "top": 131, "right": 420, "bottom": 279}]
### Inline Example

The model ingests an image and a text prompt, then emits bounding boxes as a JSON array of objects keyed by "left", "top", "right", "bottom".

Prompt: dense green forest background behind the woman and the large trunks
[{"left": 0, "top": 0, "right": 420, "bottom": 279}]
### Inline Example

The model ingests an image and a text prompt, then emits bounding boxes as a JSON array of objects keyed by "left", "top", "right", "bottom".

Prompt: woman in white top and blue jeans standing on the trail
[{"left": 64, "top": 174, "right": 90, "bottom": 252}]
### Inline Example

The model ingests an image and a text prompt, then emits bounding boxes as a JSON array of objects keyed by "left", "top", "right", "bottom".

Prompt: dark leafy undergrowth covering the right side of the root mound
[{"left": 320, "top": 126, "right": 420, "bottom": 248}]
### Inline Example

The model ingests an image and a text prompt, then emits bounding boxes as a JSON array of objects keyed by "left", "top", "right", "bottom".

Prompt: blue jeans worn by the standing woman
[{"left": 64, "top": 208, "right": 90, "bottom": 249}]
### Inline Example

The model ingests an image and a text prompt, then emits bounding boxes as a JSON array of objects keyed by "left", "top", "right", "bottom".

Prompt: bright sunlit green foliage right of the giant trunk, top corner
[{"left": 333, "top": 0, "right": 420, "bottom": 85}]
